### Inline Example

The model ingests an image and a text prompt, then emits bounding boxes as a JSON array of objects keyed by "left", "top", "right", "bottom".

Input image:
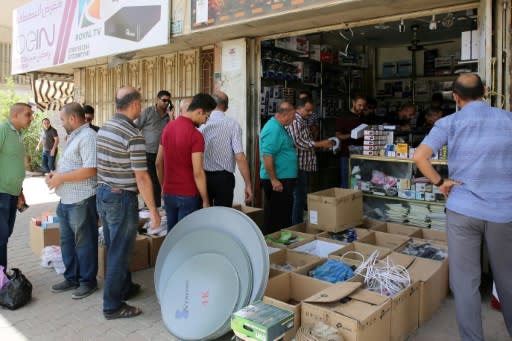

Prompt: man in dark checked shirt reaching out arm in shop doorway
[{"left": 286, "top": 98, "right": 332, "bottom": 225}]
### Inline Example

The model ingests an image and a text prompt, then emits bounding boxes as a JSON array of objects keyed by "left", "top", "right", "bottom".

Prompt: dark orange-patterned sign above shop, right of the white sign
[{"left": 191, "top": 0, "right": 332, "bottom": 30}]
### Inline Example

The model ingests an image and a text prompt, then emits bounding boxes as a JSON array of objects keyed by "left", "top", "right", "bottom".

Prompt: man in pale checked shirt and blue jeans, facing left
[{"left": 46, "top": 103, "right": 98, "bottom": 299}]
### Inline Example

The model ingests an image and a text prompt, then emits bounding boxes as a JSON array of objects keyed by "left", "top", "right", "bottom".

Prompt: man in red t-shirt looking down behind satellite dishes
[{"left": 156, "top": 94, "right": 217, "bottom": 231}]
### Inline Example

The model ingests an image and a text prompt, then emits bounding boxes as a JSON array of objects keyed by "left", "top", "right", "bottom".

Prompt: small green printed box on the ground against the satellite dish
[{"left": 231, "top": 301, "right": 294, "bottom": 341}]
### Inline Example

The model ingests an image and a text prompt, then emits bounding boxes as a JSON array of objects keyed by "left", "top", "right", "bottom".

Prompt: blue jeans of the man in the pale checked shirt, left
[{"left": 57, "top": 195, "right": 98, "bottom": 288}]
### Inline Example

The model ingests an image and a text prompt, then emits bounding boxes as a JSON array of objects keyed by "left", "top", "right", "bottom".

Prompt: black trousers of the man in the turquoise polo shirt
[{"left": 261, "top": 179, "right": 296, "bottom": 234}]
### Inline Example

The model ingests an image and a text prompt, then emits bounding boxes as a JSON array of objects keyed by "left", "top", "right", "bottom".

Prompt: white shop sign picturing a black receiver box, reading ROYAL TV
[{"left": 12, "top": 0, "right": 169, "bottom": 74}]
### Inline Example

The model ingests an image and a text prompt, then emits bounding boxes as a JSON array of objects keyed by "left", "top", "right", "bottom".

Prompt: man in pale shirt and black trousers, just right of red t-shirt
[{"left": 199, "top": 91, "right": 252, "bottom": 207}]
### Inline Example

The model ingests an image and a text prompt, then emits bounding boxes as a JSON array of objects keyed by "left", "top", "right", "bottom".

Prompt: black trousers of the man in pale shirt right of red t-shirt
[{"left": 205, "top": 171, "right": 235, "bottom": 207}]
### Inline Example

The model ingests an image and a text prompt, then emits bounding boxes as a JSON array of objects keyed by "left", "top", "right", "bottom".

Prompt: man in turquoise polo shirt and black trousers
[{"left": 260, "top": 101, "right": 298, "bottom": 234}]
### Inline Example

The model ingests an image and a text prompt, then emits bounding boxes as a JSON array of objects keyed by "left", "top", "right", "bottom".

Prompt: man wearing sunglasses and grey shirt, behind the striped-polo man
[{"left": 135, "top": 90, "right": 172, "bottom": 207}]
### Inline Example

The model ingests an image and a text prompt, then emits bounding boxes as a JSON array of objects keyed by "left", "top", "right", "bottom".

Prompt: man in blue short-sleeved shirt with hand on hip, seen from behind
[{"left": 414, "top": 74, "right": 512, "bottom": 341}]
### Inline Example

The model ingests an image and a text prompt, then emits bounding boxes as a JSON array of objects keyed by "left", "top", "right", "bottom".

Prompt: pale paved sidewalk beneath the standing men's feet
[{"left": 0, "top": 177, "right": 509, "bottom": 341}]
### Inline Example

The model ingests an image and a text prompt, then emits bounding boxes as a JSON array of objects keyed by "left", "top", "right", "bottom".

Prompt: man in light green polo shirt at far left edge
[{"left": 0, "top": 103, "right": 32, "bottom": 269}]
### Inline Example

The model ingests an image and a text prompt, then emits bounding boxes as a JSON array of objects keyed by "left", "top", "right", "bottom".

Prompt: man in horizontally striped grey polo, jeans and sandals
[{"left": 96, "top": 87, "right": 160, "bottom": 320}]
